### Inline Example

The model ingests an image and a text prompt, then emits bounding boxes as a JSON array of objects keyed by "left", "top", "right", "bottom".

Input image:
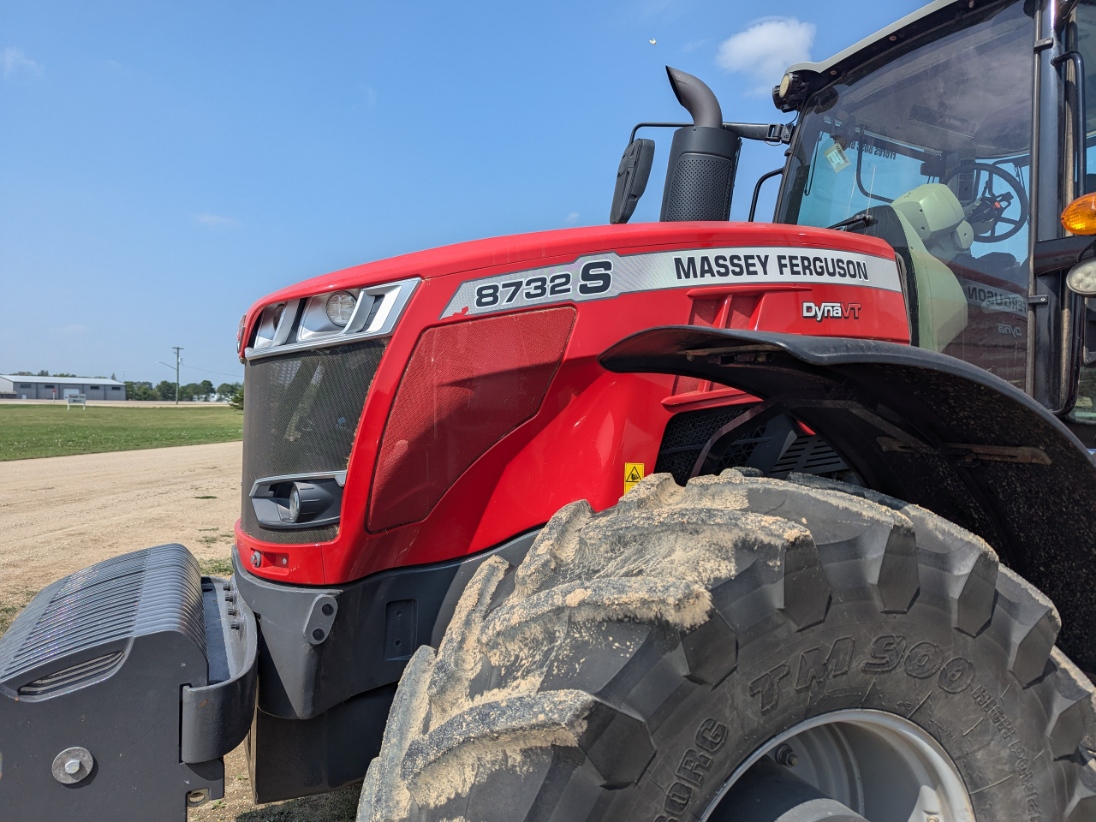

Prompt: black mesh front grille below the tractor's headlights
[{"left": 241, "top": 340, "right": 385, "bottom": 544}]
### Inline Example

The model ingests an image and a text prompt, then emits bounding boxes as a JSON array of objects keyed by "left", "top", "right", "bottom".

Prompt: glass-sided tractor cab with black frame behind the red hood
[{"left": 773, "top": 2, "right": 1096, "bottom": 434}]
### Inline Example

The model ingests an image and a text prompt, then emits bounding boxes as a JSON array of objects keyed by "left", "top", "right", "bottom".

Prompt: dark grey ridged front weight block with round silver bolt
[{"left": 0, "top": 545, "right": 258, "bottom": 820}]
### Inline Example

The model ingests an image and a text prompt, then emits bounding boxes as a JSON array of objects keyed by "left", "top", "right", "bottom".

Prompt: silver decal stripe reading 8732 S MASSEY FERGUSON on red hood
[{"left": 442, "top": 246, "right": 902, "bottom": 317}]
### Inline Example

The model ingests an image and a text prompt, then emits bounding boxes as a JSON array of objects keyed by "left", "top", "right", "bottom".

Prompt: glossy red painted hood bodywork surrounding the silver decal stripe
[{"left": 237, "top": 222, "right": 909, "bottom": 584}]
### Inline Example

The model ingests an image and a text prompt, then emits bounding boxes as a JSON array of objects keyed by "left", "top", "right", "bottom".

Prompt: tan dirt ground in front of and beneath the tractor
[{"left": 0, "top": 443, "right": 358, "bottom": 822}]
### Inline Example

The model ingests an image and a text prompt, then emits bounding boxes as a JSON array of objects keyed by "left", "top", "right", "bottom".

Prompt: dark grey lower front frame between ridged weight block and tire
[{"left": 232, "top": 532, "right": 536, "bottom": 802}]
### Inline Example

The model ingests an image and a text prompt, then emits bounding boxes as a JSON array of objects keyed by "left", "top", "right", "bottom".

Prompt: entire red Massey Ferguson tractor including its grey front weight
[{"left": 0, "top": 0, "right": 1096, "bottom": 822}]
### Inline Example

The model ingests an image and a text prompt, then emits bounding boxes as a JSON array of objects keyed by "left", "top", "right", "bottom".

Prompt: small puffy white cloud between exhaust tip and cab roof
[{"left": 716, "top": 18, "right": 818, "bottom": 94}]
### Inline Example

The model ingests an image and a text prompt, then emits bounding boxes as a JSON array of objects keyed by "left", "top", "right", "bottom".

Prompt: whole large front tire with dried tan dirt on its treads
[{"left": 358, "top": 471, "right": 1096, "bottom": 822}]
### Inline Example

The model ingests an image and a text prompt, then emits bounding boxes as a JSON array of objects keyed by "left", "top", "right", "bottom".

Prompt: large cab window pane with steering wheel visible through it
[{"left": 778, "top": 3, "right": 1034, "bottom": 387}]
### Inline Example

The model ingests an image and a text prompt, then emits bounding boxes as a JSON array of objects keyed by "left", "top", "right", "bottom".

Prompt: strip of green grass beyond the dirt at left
[{"left": 0, "top": 403, "right": 243, "bottom": 461}]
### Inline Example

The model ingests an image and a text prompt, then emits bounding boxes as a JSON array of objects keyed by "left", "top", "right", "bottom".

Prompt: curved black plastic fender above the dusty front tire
[{"left": 598, "top": 327, "right": 1096, "bottom": 672}]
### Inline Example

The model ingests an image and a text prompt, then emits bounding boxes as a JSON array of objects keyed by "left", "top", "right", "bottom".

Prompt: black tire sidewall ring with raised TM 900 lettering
[{"left": 620, "top": 601, "right": 1063, "bottom": 822}]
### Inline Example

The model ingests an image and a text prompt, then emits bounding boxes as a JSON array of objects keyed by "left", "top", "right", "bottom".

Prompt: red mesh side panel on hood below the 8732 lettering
[{"left": 368, "top": 307, "right": 575, "bottom": 532}]
